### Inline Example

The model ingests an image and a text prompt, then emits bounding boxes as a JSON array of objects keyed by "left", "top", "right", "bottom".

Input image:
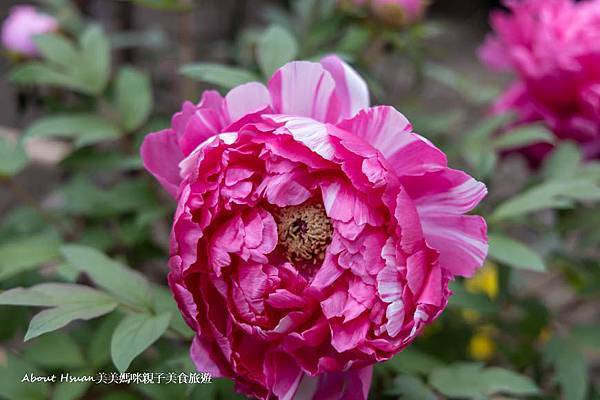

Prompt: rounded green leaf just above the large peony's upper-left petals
[{"left": 256, "top": 25, "right": 298, "bottom": 79}]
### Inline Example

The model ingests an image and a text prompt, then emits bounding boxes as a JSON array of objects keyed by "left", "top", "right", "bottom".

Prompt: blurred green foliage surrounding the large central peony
[{"left": 0, "top": 0, "right": 600, "bottom": 400}]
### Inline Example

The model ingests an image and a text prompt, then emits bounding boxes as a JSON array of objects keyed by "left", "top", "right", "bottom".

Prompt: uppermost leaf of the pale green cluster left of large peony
[{"left": 61, "top": 245, "right": 153, "bottom": 309}]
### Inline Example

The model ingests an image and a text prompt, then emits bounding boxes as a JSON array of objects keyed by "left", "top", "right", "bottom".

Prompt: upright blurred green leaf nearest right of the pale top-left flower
[{"left": 79, "top": 25, "right": 111, "bottom": 94}]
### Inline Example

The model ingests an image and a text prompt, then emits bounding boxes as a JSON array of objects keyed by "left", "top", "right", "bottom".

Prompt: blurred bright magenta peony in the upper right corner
[{"left": 479, "top": 0, "right": 600, "bottom": 164}]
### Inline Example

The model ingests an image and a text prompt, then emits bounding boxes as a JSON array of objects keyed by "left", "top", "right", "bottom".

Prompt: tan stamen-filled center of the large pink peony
[{"left": 275, "top": 203, "right": 333, "bottom": 266}]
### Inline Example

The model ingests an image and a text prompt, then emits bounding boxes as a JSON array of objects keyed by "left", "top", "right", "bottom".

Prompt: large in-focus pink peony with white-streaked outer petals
[{"left": 141, "top": 56, "right": 487, "bottom": 400}]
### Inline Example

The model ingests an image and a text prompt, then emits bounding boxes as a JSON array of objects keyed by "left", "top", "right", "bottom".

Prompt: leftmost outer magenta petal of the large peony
[{"left": 141, "top": 129, "right": 183, "bottom": 197}]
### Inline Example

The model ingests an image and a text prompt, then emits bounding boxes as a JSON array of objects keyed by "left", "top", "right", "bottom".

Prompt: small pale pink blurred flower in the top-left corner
[{"left": 2, "top": 6, "right": 59, "bottom": 57}]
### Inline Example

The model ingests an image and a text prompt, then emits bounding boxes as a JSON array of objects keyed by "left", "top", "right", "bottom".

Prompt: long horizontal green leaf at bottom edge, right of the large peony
[{"left": 429, "top": 363, "right": 539, "bottom": 399}]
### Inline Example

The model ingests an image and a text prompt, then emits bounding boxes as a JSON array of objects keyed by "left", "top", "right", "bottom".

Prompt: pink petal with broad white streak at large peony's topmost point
[{"left": 320, "top": 55, "right": 369, "bottom": 118}]
